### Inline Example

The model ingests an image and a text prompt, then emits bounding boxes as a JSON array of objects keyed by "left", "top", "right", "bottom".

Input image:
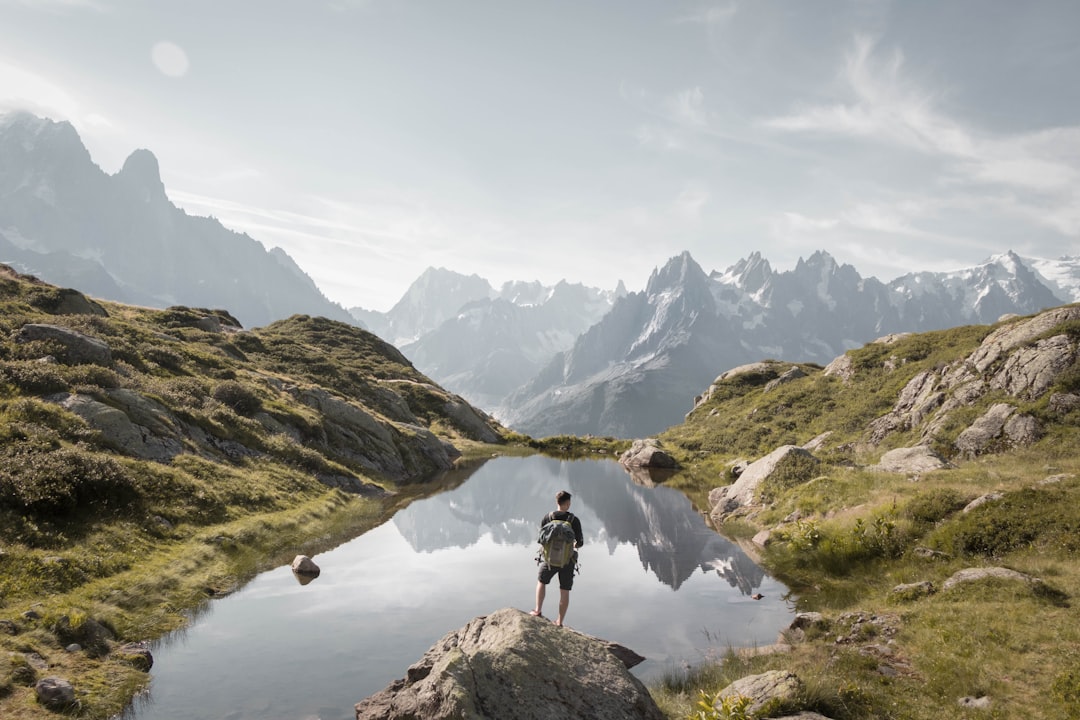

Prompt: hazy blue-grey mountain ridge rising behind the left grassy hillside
[{"left": 0, "top": 112, "right": 354, "bottom": 327}]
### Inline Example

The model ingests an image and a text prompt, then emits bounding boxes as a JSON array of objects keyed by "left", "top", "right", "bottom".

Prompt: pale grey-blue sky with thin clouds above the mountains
[{"left": 0, "top": 0, "right": 1080, "bottom": 310}]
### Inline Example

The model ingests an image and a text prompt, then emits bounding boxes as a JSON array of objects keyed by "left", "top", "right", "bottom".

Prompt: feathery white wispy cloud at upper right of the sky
[{"left": 762, "top": 37, "right": 1080, "bottom": 249}]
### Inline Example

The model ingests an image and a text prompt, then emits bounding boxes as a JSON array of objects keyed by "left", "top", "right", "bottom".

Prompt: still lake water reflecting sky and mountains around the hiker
[{"left": 127, "top": 456, "right": 793, "bottom": 720}]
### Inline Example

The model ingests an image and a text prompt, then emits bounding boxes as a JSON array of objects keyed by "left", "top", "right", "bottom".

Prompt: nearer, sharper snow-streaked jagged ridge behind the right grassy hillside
[{"left": 494, "top": 252, "right": 1080, "bottom": 437}]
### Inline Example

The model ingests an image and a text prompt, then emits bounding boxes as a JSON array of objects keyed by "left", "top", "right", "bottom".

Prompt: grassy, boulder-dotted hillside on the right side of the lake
[{"left": 654, "top": 309, "right": 1080, "bottom": 720}]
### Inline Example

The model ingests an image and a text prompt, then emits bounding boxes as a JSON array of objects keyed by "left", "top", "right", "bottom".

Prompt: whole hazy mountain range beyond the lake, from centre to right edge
[{"left": 362, "top": 252, "right": 1080, "bottom": 437}]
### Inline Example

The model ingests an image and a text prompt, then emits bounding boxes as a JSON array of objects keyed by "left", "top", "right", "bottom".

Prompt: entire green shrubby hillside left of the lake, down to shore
[{"left": 0, "top": 266, "right": 507, "bottom": 719}]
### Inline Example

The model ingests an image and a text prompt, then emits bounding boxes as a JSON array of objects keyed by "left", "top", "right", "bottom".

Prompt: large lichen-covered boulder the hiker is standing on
[{"left": 355, "top": 609, "right": 664, "bottom": 720}]
